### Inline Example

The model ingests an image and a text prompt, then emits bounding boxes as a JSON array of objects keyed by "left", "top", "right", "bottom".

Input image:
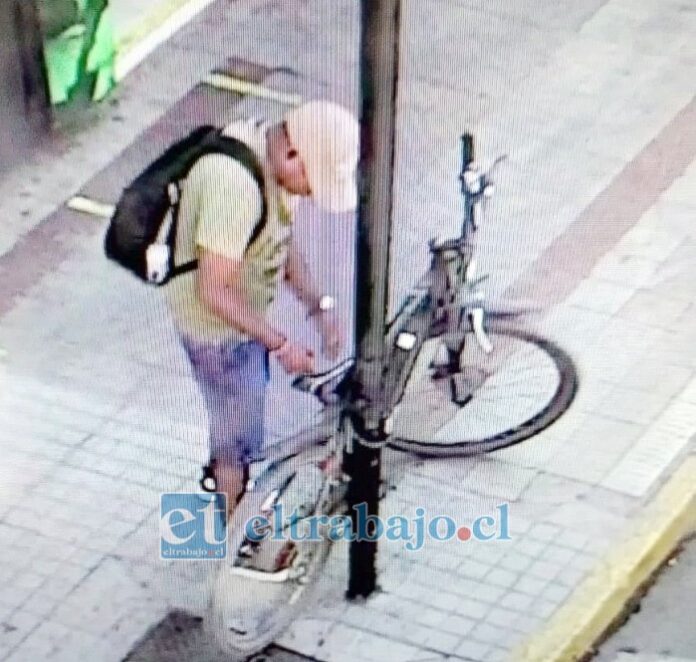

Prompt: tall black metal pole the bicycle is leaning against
[{"left": 346, "top": 0, "right": 401, "bottom": 598}]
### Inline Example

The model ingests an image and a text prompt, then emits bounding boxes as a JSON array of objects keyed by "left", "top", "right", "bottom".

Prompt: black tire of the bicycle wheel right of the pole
[{"left": 389, "top": 327, "right": 578, "bottom": 457}]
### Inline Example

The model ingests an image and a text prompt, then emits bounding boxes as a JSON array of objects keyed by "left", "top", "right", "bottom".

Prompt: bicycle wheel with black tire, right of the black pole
[{"left": 391, "top": 329, "right": 578, "bottom": 457}]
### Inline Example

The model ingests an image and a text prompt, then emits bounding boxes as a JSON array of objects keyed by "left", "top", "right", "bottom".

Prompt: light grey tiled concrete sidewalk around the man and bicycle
[{"left": 0, "top": 0, "right": 696, "bottom": 662}]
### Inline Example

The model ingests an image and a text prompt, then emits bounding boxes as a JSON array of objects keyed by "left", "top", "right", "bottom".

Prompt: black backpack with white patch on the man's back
[{"left": 104, "top": 126, "right": 267, "bottom": 285}]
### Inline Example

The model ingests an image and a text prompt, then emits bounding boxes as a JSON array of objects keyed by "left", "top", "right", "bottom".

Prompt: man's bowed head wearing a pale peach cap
[{"left": 268, "top": 101, "right": 360, "bottom": 212}]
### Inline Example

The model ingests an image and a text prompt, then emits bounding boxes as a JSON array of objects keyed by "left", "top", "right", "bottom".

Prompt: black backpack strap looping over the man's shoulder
[{"left": 170, "top": 129, "right": 268, "bottom": 278}]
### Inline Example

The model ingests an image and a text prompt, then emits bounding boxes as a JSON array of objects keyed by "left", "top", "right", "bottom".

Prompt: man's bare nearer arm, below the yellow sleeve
[{"left": 197, "top": 251, "right": 285, "bottom": 349}]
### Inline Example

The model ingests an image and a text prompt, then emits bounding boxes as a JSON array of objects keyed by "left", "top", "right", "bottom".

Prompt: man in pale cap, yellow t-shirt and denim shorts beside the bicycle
[{"left": 167, "top": 101, "right": 359, "bottom": 513}]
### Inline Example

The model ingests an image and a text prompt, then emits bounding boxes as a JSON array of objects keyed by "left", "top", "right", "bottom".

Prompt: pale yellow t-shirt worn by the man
[{"left": 164, "top": 121, "right": 292, "bottom": 342}]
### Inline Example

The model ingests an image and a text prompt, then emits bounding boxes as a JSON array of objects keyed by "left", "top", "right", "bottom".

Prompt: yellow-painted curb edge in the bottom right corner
[{"left": 510, "top": 455, "right": 696, "bottom": 662}]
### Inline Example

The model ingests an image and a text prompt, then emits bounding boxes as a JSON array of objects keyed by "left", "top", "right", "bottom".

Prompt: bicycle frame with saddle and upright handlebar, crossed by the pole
[{"left": 253, "top": 134, "right": 501, "bottom": 477}]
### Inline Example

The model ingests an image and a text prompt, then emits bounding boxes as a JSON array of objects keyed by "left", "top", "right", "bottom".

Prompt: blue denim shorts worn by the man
[{"left": 181, "top": 336, "right": 269, "bottom": 465}]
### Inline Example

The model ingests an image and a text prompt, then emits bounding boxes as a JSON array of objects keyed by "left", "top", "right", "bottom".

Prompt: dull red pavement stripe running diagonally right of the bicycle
[{"left": 504, "top": 97, "right": 696, "bottom": 308}]
